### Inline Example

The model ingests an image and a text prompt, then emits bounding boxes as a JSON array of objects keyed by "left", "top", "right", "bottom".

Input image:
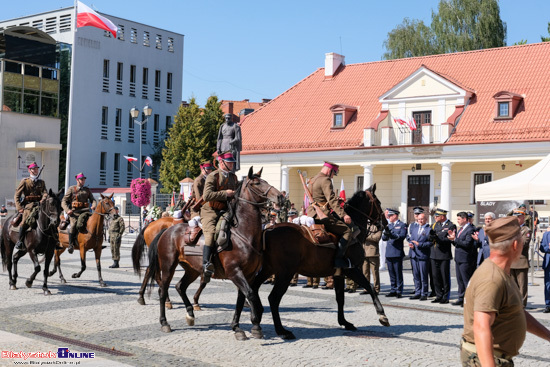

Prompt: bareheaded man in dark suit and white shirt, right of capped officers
[{"left": 448, "top": 212, "right": 477, "bottom": 307}]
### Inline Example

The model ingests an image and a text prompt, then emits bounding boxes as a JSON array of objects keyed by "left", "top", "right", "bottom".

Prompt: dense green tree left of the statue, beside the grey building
[{"left": 160, "top": 96, "right": 223, "bottom": 193}]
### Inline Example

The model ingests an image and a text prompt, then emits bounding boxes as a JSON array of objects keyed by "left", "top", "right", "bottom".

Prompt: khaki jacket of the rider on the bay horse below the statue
[{"left": 201, "top": 169, "right": 239, "bottom": 218}]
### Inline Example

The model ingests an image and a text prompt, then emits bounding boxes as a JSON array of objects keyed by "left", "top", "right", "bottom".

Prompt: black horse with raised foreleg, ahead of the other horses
[{"left": 233, "top": 184, "right": 389, "bottom": 339}]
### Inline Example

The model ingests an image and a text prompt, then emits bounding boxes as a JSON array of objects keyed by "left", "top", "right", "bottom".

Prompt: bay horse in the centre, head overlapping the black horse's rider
[{"left": 138, "top": 168, "right": 283, "bottom": 340}]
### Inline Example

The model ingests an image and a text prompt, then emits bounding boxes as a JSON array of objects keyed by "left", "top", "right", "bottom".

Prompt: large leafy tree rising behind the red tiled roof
[{"left": 383, "top": 0, "right": 506, "bottom": 59}]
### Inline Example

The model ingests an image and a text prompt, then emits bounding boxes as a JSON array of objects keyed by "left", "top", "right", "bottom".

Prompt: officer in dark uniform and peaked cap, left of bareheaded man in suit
[{"left": 430, "top": 209, "right": 456, "bottom": 303}]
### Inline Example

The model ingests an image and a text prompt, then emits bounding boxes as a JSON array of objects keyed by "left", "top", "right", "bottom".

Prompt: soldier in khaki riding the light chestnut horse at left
[{"left": 61, "top": 172, "right": 97, "bottom": 254}]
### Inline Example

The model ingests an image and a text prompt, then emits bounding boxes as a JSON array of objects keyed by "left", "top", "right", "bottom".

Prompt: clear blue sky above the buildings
[{"left": 4, "top": 0, "right": 550, "bottom": 105}]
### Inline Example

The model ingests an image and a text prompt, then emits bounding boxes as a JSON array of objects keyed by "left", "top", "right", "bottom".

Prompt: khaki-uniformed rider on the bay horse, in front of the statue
[{"left": 201, "top": 152, "right": 239, "bottom": 283}]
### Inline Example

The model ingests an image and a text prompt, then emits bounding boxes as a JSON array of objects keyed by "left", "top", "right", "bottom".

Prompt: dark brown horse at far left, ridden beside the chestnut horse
[{"left": 0, "top": 189, "right": 62, "bottom": 295}]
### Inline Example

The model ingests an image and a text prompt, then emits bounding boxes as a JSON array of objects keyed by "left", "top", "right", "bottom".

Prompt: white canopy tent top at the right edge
[{"left": 475, "top": 154, "right": 550, "bottom": 201}]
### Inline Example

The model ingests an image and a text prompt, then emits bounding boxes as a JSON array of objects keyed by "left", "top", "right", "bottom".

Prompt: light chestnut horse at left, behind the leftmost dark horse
[{"left": 50, "top": 194, "right": 115, "bottom": 287}]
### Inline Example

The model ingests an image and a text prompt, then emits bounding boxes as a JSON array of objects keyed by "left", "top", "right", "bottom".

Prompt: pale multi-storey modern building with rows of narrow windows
[{"left": 0, "top": 7, "right": 183, "bottom": 198}]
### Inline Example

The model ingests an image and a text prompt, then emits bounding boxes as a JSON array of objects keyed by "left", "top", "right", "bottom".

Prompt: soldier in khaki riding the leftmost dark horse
[{"left": 14, "top": 162, "right": 48, "bottom": 250}]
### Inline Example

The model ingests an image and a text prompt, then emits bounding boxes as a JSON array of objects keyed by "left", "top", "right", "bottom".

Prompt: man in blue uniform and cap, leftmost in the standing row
[{"left": 382, "top": 209, "right": 407, "bottom": 298}]
